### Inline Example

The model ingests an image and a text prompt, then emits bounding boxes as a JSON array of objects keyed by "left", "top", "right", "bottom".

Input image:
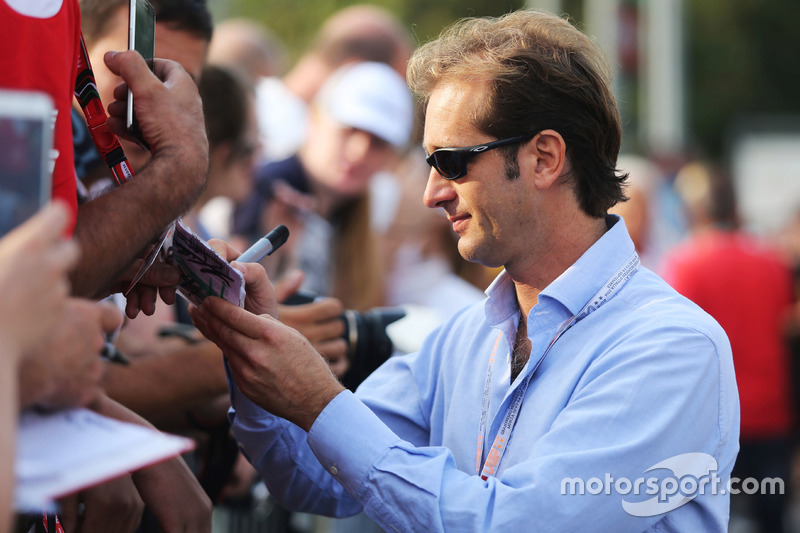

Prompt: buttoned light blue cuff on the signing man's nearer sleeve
[{"left": 308, "top": 390, "right": 401, "bottom": 496}]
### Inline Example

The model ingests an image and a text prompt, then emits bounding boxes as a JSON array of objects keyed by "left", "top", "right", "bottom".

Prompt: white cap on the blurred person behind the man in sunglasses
[{"left": 317, "top": 62, "right": 414, "bottom": 147}]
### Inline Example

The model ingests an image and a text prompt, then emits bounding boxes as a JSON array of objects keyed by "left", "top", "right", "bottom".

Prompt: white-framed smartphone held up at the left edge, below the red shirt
[{"left": 0, "top": 89, "right": 56, "bottom": 236}]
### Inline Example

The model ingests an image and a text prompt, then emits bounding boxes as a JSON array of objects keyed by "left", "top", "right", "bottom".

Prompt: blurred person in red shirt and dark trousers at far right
[{"left": 663, "top": 162, "right": 795, "bottom": 533}]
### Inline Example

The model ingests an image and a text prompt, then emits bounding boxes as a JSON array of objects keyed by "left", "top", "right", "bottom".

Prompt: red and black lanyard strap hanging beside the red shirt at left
[{"left": 75, "top": 35, "right": 133, "bottom": 185}]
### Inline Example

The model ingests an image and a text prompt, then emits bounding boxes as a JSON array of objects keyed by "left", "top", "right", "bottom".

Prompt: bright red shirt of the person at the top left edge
[{"left": 0, "top": 0, "right": 81, "bottom": 233}]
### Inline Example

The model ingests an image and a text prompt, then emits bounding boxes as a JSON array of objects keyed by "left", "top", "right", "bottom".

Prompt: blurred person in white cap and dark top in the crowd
[{"left": 228, "top": 62, "right": 413, "bottom": 310}]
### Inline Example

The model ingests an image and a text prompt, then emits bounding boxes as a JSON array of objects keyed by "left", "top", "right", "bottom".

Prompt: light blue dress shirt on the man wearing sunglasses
[{"left": 231, "top": 216, "right": 739, "bottom": 532}]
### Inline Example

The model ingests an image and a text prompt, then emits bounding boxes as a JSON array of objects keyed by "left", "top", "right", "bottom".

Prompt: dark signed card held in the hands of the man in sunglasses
[{"left": 164, "top": 220, "right": 244, "bottom": 307}]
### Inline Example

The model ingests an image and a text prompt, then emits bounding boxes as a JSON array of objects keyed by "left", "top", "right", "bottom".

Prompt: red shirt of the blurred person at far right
[{"left": 664, "top": 229, "right": 794, "bottom": 439}]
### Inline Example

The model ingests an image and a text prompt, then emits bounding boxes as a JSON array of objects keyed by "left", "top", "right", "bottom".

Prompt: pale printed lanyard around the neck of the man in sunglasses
[{"left": 475, "top": 252, "right": 639, "bottom": 481}]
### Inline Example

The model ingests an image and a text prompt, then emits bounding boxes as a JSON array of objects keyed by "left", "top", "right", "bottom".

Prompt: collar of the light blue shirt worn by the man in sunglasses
[{"left": 484, "top": 215, "right": 634, "bottom": 325}]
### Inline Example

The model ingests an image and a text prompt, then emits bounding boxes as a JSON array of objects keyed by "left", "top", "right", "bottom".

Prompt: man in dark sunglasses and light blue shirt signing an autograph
[{"left": 193, "top": 11, "right": 739, "bottom": 532}]
